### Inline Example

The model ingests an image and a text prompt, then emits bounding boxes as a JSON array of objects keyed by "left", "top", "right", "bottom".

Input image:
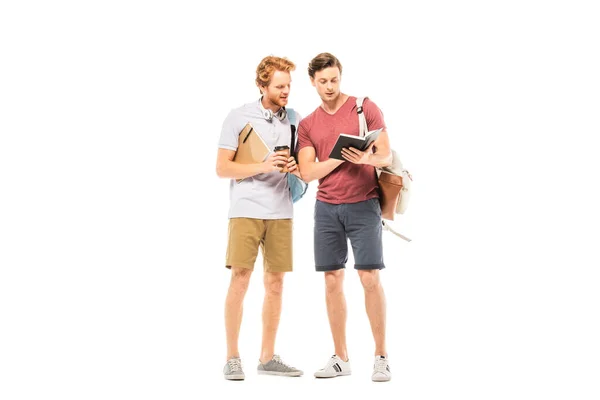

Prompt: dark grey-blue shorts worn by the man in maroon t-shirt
[{"left": 314, "top": 198, "right": 385, "bottom": 271}]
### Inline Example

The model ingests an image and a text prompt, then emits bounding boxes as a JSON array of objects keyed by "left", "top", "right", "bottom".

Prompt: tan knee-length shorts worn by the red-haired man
[{"left": 225, "top": 218, "right": 292, "bottom": 272}]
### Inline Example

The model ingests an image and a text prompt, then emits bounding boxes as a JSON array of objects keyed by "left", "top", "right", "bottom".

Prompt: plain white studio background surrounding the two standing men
[{"left": 0, "top": 0, "right": 600, "bottom": 399}]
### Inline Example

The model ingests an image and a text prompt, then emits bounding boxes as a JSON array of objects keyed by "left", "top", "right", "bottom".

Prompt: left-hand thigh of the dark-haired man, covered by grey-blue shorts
[{"left": 314, "top": 200, "right": 348, "bottom": 271}]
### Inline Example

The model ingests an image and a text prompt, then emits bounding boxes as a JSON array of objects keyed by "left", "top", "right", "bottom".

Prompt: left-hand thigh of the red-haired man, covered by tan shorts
[{"left": 225, "top": 218, "right": 264, "bottom": 270}]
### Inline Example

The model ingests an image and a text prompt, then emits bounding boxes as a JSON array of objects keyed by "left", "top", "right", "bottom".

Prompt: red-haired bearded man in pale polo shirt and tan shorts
[{"left": 217, "top": 56, "right": 302, "bottom": 380}]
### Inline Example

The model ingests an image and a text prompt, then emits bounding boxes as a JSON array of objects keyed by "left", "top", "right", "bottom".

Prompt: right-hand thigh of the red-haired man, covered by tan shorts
[{"left": 263, "top": 219, "right": 293, "bottom": 272}]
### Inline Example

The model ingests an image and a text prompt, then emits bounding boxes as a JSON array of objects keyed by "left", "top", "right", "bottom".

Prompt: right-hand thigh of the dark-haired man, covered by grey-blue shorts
[{"left": 345, "top": 198, "right": 385, "bottom": 269}]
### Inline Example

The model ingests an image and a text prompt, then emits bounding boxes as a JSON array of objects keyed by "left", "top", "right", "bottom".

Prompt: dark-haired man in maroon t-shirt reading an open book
[{"left": 298, "top": 53, "right": 392, "bottom": 381}]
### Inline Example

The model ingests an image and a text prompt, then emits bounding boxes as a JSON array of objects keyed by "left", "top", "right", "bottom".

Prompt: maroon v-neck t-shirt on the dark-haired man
[{"left": 298, "top": 96, "right": 386, "bottom": 204}]
